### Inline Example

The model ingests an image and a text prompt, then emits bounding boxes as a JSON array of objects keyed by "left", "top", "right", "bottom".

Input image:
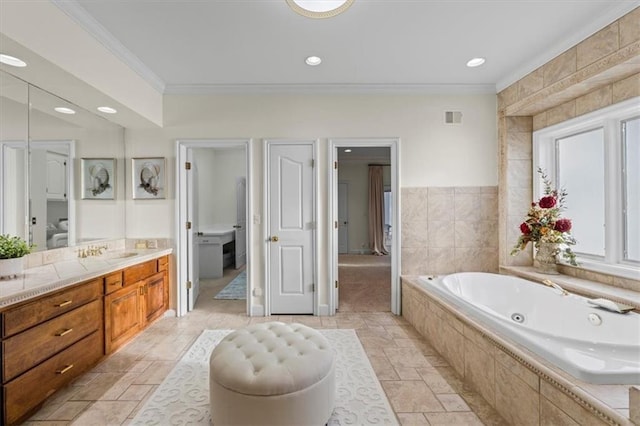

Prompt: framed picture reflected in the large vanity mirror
[{"left": 80, "top": 158, "right": 116, "bottom": 200}]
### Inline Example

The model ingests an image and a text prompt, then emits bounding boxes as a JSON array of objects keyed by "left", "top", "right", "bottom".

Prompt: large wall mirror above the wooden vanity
[{"left": 0, "top": 71, "right": 125, "bottom": 251}]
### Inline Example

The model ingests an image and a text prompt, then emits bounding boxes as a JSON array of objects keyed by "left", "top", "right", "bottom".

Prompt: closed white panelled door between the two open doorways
[{"left": 266, "top": 143, "right": 315, "bottom": 314}]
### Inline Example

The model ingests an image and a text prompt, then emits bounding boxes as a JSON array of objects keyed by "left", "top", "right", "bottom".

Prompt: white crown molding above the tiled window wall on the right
[{"left": 495, "top": 0, "right": 640, "bottom": 93}]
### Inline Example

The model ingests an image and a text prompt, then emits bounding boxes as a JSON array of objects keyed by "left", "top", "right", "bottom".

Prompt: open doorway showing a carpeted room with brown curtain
[{"left": 329, "top": 140, "right": 399, "bottom": 313}]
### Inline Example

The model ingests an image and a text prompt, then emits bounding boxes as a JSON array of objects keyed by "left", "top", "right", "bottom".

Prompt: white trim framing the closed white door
[{"left": 262, "top": 139, "right": 322, "bottom": 316}]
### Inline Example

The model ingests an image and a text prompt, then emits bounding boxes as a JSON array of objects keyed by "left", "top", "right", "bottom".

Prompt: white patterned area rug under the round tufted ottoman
[{"left": 131, "top": 330, "right": 398, "bottom": 426}]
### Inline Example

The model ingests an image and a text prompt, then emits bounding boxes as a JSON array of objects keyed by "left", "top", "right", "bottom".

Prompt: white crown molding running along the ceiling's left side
[{"left": 50, "top": 0, "right": 165, "bottom": 93}]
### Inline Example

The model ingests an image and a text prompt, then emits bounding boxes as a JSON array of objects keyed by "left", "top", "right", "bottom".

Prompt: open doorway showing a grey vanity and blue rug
[{"left": 177, "top": 140, "right": 251, "bottom": 315}]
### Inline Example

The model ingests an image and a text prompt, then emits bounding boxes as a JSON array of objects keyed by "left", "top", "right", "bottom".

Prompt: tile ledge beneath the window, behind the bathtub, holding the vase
[{"left": 500, "top": 266, "right": 640, "bottom": 311}]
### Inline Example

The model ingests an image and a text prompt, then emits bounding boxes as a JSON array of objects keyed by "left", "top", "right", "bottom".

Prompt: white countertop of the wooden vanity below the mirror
[{"left": 0, "top": 248, "right": 173, "bottom": 308}]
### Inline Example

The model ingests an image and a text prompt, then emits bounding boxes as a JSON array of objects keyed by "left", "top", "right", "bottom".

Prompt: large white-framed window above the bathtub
[{"left": 533, "top": 98, "right": 640, "bottom": 277}]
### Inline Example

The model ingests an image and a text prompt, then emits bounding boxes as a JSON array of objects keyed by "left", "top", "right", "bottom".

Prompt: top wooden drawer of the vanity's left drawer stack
[{"left": 2, "top": 278, "right": 103, "bottom": 337}]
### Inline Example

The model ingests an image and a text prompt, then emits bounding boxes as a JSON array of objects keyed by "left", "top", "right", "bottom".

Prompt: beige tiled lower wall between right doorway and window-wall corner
[{"left": 401, "top": 186, "right": 498, "bottom": 275}]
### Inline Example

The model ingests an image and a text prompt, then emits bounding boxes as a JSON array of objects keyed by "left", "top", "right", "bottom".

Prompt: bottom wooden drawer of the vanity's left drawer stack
[{"left": 3, "top": 330, "right": 103, "bottom": 424}]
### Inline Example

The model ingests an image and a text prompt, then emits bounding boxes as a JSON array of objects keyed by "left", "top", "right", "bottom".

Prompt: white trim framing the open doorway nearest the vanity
[{"left": 176, "top": 139, "right": 253, "bottom": 316}]
